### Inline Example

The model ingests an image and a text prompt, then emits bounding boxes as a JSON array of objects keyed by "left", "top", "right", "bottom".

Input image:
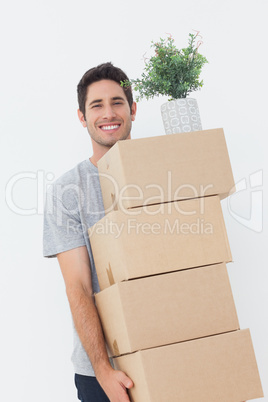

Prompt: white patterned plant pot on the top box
[{"left": 161, "top": 98, "right": 202, "bottom": 134}]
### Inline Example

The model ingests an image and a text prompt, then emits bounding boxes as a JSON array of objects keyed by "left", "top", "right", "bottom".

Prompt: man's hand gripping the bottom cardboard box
[{"left": 97, "top": 367, "right": 133, "bottom": 402}]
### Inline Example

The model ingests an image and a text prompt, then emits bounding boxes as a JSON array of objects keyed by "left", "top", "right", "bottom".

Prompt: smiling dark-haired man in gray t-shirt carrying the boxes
[{"left": 44, "top": 63, "right": 136, "bottom": 402}]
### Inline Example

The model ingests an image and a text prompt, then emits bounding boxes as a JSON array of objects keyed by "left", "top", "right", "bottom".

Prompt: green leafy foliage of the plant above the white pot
[{"left": 121, "top": 33, "right": 208, "bottom": 101}]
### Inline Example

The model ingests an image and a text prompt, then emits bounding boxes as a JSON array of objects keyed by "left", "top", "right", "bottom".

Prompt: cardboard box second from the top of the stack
[{"left": 89, "top": 196, "right": 232, "bottom": 290}]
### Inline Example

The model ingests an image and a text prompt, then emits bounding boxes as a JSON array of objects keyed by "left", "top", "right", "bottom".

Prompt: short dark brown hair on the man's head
[{"left": 77, "top": 62, "right": 133, "bottom": 117}]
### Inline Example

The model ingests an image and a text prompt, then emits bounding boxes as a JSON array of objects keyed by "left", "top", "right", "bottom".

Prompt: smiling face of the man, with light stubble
[{"left": 78, "top": 80, "right": 136, "bottom": 148}]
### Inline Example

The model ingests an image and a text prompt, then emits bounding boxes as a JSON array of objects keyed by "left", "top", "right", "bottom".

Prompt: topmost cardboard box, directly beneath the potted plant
[{"left": 98, "top": 129, "right": 234, "bottom": 213}]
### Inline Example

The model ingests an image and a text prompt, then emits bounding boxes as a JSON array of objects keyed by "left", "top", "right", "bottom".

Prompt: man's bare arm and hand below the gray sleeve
[{"left": 57, "top": 246, "right": 133, "bottom": 402}]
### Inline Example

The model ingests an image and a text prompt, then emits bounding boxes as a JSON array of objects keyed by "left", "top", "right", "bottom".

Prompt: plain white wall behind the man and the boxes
[{"left": 0, "top": 0, "right": 268, "bottom": 402}]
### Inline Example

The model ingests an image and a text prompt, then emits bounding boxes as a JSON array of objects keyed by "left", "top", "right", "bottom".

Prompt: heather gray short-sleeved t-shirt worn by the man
[{"left": 44, "top": 159, "right": 104, "bottom": 376}]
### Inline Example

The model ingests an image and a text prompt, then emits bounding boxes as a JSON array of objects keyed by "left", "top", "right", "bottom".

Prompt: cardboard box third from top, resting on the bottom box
[{"left": 95, "top": 264, "right": 239, "bottom": 356}]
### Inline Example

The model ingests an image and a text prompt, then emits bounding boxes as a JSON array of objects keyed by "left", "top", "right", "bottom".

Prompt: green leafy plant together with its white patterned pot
[{"left": 121, "top": 32, "right": 208, "bottom": 134}]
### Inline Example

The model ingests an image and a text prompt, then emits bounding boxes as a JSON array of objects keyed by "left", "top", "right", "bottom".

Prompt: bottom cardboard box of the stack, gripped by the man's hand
[{"left": 114, "top": 329, "right": 263, "bottom": 402}]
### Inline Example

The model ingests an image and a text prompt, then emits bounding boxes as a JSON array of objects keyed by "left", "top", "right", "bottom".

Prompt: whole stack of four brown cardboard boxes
[{"left": 89, "top": 129, "right": 263, "bottom": 402}]
